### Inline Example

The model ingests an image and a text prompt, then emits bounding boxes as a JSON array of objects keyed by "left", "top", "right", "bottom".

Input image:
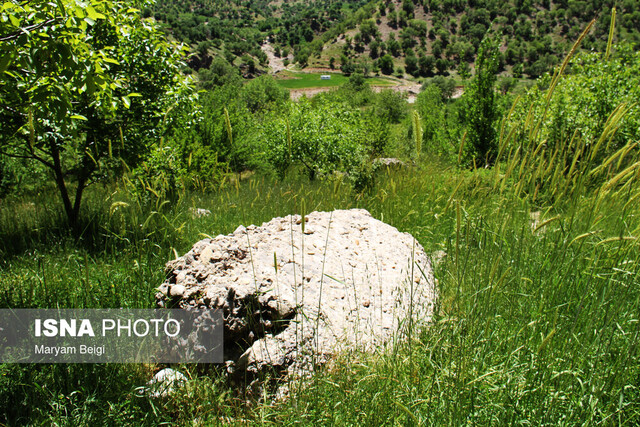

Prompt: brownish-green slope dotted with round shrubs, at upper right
[{"left": 310, "top": 0, "right": 640, "bottom": 78}]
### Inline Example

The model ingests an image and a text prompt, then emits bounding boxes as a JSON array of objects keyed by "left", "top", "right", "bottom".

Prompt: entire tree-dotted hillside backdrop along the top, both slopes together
[{"left": 151, "top": 0, "right": 640, "bottom": 77}]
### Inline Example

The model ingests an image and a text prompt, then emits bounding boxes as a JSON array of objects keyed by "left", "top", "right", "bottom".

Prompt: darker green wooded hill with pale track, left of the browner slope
[{"left": 148, "top": 0, "right": 367, "bottom": 69}]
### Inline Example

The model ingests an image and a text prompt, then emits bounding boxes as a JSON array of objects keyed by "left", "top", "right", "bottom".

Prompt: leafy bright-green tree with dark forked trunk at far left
[{"left": 0, "top": 0, "right": 190, "bottom": 230}]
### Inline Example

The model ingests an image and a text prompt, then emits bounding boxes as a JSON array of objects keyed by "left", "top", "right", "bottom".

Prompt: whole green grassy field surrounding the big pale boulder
[{"left": 0, "top": 149, "right": 640, "bottom": 425}]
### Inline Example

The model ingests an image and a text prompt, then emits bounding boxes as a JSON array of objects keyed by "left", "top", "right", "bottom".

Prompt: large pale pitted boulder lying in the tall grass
[{"left": 156, "top": 209, "right": 436, "bottom": 375}]
